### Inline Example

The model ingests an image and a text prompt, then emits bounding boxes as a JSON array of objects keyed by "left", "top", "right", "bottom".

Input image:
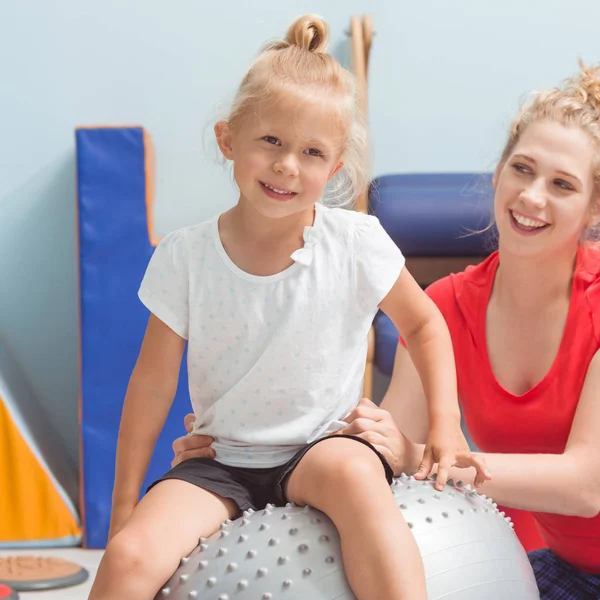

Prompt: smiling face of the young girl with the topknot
[{"left": 215, "top": 93, "right": 344, "bottom": 224}]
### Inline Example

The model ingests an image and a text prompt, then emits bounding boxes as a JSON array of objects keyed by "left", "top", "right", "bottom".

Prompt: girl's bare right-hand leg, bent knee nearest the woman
[{"left": 286, "top": 436, "right": 427, "bottom": 600}]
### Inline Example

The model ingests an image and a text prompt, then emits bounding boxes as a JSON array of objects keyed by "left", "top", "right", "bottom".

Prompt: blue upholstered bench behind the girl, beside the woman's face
[{"left": 369, "top": 173, "right": 493, "bottom": 375}]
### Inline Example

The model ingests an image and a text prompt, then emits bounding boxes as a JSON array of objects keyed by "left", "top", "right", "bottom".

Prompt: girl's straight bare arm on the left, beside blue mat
[{"left": 110, "top": 314, "right": 186, "bottom": 537}]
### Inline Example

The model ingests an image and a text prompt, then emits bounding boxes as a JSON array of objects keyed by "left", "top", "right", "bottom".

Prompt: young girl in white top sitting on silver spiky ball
[{"left": 90, "top": 16, "right": 487, "bottom": 600}]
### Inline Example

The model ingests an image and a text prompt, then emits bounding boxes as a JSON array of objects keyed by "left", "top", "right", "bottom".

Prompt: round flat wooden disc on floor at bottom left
[{"left": 0, "top": 556, "right": 89, "bottom": 600}]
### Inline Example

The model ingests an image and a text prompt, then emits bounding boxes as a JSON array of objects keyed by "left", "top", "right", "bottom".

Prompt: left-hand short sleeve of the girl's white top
[{"left": 138, "top": 231, "right": 189, "bottom": 339}]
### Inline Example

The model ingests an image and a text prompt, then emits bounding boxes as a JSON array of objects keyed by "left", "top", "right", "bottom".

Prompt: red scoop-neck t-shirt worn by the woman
[{"left": 408, "top": 248, "right": 600, "bottom": 573}]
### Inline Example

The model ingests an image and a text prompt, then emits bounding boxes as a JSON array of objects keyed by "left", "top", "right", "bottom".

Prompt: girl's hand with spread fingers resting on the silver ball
[{"left": 415, "top": 425, "right": 492, "bottom": 490}]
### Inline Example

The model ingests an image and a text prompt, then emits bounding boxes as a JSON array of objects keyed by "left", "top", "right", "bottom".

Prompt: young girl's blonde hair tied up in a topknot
[{"left": 226, "top": 15, "right": 369, "bottom": 205}]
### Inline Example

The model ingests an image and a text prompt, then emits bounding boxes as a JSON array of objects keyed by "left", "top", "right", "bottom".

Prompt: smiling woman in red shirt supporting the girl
[{"left": 174, "top": 63, "right": 600, "bottom": 600}]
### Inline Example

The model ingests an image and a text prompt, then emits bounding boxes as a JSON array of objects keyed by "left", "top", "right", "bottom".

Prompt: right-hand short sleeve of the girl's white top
[{"left": 353, "top": 215, "right": 405, "bottom": 310}]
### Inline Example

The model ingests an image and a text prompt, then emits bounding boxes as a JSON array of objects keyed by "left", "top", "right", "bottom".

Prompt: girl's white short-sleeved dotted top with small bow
[{"left": 139, "top": 204, "right": 404, "bottom": 468}]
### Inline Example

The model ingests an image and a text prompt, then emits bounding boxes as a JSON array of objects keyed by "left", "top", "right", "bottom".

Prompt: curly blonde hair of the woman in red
[{"left": 500, "top": 61, "right": 600, "bottom": 238}]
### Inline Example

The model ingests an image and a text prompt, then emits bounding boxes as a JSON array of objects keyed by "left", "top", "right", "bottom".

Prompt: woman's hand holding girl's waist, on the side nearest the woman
[{"left": 337, "top": 398, "right": 420, "bottom": 476}]
